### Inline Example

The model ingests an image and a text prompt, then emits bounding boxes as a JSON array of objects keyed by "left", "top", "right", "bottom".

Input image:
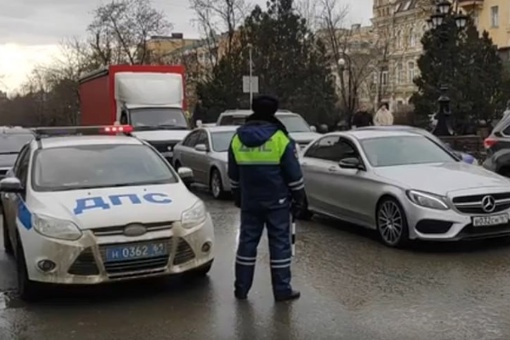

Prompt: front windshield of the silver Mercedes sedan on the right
[{"left": 360, "top": 136, "right": 457, "bottom": 167}]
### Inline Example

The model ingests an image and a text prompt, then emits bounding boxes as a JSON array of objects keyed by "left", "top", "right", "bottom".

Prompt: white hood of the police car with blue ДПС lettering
[{"left": 31, "top": 183, "right": 199, "bottom": 230}]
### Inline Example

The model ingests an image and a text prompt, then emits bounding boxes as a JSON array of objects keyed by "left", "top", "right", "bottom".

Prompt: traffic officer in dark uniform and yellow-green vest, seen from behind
[{"left": 228, "top": 96, "right": 305, "bottom": 301}]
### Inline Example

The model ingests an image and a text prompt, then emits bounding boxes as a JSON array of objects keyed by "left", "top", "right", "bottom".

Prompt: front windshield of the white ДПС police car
[{"left": 32, "top": 144, "right": 178, "bottom": 191}]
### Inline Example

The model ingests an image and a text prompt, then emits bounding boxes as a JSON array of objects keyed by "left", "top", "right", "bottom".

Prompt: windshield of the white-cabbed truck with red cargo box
[{"left": 130, "top": 107, "right": 188, "bottom": 129}]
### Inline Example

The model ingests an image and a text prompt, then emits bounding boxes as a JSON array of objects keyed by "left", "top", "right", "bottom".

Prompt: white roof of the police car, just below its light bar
[{"left": 32, "top": 135, "right": 143, "bottom": 149}]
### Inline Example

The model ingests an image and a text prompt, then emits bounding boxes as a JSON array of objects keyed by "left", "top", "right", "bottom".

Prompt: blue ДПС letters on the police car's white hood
[{"left": 73, "top": 192, "right": 172, "bottom": 215}]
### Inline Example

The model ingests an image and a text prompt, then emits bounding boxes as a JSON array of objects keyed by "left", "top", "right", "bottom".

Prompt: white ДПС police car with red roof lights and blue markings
[{"left": 0, "top": 126, "right": 214, "bottom": 299}]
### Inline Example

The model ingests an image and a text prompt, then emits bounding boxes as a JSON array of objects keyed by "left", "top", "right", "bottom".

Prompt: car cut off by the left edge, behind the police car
[{"left": 0, "top": 126, "right": 34, "bottom": 179}]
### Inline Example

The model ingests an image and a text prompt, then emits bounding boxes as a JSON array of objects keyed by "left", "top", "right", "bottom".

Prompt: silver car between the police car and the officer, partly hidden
[{"left": 173, "top": 126, "right": 237, "bottom": 199}]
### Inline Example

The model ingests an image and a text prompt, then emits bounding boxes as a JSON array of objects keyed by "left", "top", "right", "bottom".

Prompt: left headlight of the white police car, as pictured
[{"left": 32, "top": 214, "right": 82, "bottom": 241}]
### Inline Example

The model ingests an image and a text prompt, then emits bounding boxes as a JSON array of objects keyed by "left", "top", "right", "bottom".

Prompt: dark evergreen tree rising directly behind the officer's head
[{"left": 200, "top": 0, "right": 336, "bottom": 124}]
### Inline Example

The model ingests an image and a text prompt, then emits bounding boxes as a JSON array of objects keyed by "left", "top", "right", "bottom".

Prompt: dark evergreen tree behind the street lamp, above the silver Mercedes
[{"left": 411, "top": 15, "right": 503, "bottom": 133}]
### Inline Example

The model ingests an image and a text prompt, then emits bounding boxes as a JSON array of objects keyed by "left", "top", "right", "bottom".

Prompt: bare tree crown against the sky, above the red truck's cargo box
[{"left": 87, "top": 0, "right": 171, "bottom": 65}]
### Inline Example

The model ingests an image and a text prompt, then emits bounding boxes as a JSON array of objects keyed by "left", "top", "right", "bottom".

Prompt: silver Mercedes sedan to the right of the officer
[{"left": 299, "top": 130, "right": 510, "bottom": 247}]
